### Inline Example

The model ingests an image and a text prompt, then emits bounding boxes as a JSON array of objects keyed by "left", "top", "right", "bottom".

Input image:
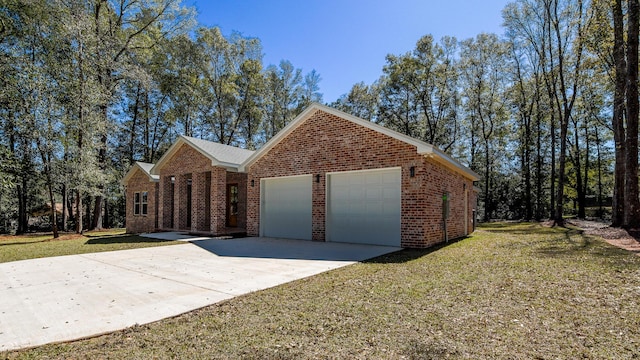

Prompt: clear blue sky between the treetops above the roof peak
[{"left": 189, "top": 0, "right": 509, "bottom": 102}]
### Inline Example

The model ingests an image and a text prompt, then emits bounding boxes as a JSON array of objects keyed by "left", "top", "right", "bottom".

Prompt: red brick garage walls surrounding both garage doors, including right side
[{"left": 247, "top": 111, "right": 472, "bottom": 248}]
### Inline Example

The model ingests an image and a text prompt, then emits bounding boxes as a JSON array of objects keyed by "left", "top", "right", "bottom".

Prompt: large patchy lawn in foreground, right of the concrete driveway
[{"left": 0, "top": 223, "right": 640, "bottom": 359}]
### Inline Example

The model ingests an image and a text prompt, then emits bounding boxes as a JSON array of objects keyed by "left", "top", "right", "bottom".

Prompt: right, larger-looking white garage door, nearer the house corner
[{"left": 327, "top": 168, "right": 402, "bottom": 246}]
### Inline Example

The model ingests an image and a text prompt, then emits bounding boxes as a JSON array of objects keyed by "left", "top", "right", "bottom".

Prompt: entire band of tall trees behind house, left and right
[{"left": 0, "top": 0, "right": 640, "bottom": 236}]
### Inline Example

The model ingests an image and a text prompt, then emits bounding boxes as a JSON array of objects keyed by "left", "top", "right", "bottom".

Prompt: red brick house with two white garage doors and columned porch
[{"left": 122, "top": 104, "right": 478, "bottom": 248}]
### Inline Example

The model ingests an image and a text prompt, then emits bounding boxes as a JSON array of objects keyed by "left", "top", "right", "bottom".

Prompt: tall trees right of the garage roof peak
[{"left": 332, "top": 0, "right": 640, "bottom": 227}]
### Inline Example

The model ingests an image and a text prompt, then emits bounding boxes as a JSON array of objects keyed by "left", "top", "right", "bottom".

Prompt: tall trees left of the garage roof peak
[{"left": 0, "top": 0, "right": 322, "bottom": 236}]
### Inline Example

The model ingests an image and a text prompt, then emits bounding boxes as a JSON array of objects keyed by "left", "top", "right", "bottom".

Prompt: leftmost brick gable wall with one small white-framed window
[{"left": 126, "top": 169, "right": 157, "bottom": 234}]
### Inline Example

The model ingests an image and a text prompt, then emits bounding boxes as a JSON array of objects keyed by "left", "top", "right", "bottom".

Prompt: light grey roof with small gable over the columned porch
[{"left": 150, "top": 135, "right": 254, "bottom": 174}]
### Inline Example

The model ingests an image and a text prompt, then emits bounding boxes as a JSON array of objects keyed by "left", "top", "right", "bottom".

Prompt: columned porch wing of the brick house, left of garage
[{"left": 123, "top": 136, "right": 253, "bottom": 235}]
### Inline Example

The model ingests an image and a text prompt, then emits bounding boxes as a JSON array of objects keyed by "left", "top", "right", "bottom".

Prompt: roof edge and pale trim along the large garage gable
[{"left": 238, "top": 103, "right": 480, "bottom": 181}]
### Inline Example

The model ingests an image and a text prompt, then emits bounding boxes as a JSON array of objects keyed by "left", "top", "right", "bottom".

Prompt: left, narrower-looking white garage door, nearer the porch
[{"left": 260, "top": 175, "right": 312, "bottom": 240}]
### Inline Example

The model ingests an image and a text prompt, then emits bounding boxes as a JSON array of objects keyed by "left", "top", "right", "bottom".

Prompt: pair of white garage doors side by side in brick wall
[{"left": 260, "top": 167, "right": 401, "bottom": 246}]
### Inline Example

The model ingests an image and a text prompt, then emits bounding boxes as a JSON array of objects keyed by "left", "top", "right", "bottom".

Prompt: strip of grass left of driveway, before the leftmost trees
[{"left": 0, "top": 229, "right": 177, "bottom": 263}]
